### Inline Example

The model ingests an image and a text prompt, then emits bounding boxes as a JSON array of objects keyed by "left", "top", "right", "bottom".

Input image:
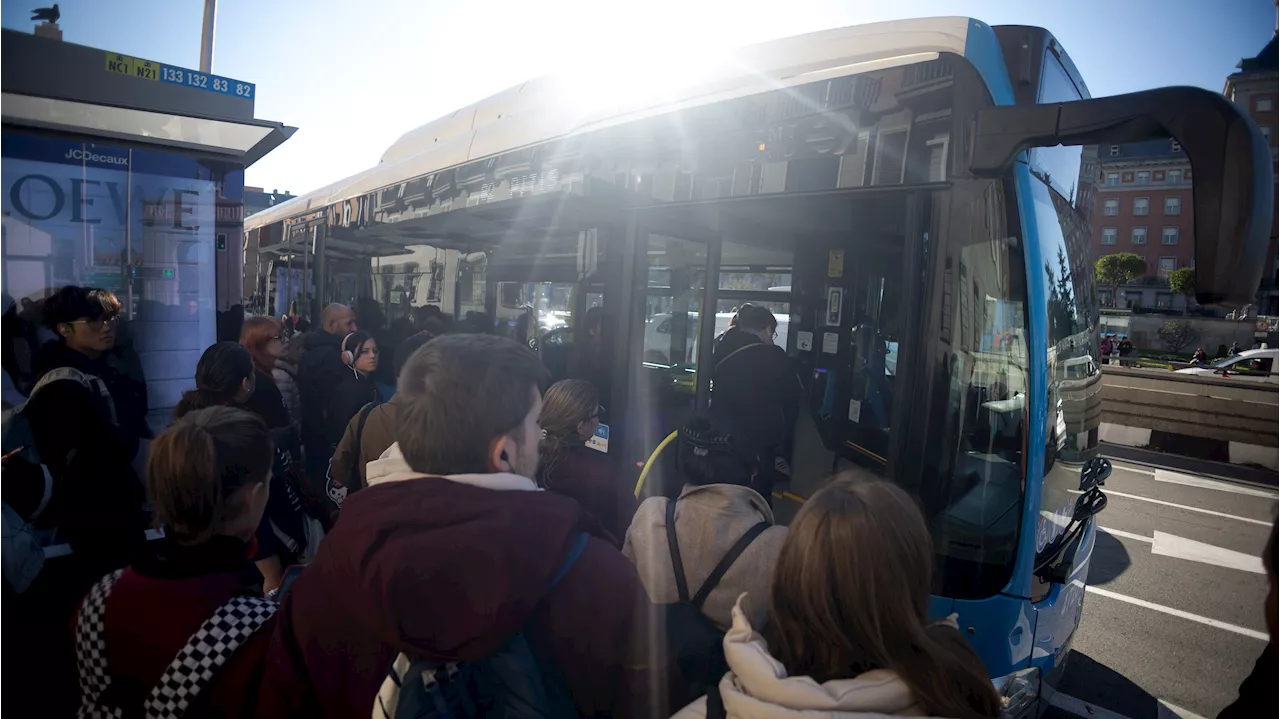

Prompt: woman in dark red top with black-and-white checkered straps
[{"left": 73, "top": 407, "right": 275, "bottom": 719}]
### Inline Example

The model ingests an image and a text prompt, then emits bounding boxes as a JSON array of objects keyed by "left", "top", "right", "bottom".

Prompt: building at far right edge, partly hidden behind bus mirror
[{"left": 1222, "top": 28, "right": 1280, "bottom": 315}]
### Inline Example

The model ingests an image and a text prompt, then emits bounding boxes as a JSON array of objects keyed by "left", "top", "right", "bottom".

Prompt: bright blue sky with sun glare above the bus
[{"left": 0, "top": 0, "right": 1275, "bottom": 193}]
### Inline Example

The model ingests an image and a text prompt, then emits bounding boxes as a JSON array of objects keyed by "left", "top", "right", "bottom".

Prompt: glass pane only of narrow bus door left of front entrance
[{"left": 627, "top": 233, "right": 708, "bottom": 494}]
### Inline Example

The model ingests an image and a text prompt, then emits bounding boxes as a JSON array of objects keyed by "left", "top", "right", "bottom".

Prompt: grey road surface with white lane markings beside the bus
[{"left": 1047, "top": 459, "right": 1277, "bottom": 719}]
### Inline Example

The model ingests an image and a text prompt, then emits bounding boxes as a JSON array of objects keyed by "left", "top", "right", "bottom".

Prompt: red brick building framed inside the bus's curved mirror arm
[{"left": 1076, "top": 139, "right": 1194, "bottom": 310}]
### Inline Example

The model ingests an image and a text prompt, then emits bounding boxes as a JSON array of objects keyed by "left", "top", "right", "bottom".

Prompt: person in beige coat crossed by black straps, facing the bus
[{"left": 622, "top": 420, "right": 787, "bottom": 629}]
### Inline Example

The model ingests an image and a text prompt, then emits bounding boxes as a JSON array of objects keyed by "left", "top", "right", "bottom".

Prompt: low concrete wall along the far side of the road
[{"left": 1100, "top": 366, "right": 1280, "bottom": 470}]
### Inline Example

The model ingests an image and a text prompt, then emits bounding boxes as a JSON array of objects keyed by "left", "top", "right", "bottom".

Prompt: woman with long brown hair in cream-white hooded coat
[{"left": 676, "top": 472, "right": 1000, "bottom": 719}]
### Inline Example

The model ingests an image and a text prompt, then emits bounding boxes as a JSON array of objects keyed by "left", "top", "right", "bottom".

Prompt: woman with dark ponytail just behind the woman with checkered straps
[{"left": 174, "top": 342, "right": 307, "bottom": 591}]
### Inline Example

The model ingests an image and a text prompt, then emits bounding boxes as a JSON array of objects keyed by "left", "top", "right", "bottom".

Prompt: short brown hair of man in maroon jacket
[{"left": 396, "top": 334, "right": 547, "bottom": 475}]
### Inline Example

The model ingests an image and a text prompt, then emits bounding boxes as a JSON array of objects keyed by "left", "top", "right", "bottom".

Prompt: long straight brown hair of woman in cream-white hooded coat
[{"left": 765, "top": 471, "right": 1000, "bottom": 719}]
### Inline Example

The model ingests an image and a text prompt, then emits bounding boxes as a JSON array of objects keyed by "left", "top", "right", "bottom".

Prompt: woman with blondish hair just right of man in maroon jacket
[{"left": 536, "top": 380, "right": 636, "bottom": 539}]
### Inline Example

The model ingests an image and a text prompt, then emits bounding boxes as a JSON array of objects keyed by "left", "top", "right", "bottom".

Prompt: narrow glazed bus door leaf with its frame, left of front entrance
[{"left": 621, "top": 211, "right": 721, "bottom": 495}]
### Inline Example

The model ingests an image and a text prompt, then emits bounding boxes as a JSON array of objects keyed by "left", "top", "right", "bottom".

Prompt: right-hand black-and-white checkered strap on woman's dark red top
[{"left": 143, "top": 596, "right": 275, "bottom": 719}]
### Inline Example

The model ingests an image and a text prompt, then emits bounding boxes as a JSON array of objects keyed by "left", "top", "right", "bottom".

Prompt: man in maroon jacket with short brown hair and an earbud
[{"left": 259, "top": 335, "right": 667, "bottom": 716}]
